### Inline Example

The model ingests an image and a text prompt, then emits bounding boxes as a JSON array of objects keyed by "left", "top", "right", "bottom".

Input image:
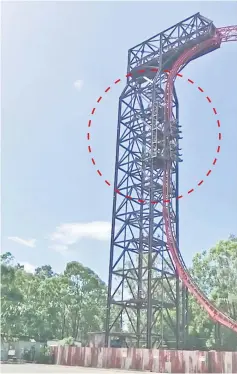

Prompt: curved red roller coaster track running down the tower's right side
[{"left": 163, "top": 26, "right": 237, "bottom": 333}]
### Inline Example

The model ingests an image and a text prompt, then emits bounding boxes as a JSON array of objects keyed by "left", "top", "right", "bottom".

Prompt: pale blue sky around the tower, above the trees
[{"left": 2, "top": 2, "right": 237, "bottom": 280}]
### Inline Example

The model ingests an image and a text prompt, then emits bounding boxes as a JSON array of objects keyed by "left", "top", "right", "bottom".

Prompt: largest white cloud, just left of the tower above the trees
[{"left": 50, "top": 221, "right": 111, "bottom": 253}]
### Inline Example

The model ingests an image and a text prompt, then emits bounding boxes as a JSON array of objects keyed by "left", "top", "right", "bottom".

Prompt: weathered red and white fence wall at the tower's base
[{"left": 54, "top": 347, "right": 237, "bottom": 373}]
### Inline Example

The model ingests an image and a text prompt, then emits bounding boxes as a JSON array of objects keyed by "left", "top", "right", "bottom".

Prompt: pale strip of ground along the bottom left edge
[{"left": 1, "top": 364, "right": 144, "bottom": 374}]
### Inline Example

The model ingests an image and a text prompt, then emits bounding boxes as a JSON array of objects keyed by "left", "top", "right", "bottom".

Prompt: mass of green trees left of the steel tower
[{"left": 1, "top": 253, "right": 106, "bottom": 342}]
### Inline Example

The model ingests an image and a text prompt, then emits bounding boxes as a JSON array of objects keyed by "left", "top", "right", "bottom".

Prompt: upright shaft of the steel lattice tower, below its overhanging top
[{"left": 105, "top": 38, "right": 182, "bottom": 348}]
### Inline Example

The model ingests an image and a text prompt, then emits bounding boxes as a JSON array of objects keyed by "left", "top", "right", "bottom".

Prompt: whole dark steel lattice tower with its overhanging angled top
[{"left": 105, "top": 13, "right": 215, "bottom": 348}]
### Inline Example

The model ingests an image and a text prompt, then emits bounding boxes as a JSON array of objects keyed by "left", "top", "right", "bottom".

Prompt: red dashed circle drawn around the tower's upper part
[{"left": 87, "top": 68, "right": 222, "bottom": 204}]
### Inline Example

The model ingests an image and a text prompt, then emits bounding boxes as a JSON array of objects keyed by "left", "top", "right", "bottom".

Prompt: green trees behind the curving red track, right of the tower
[{"left": 190, "top": 236, "right": 237, "bottom": 350}]
